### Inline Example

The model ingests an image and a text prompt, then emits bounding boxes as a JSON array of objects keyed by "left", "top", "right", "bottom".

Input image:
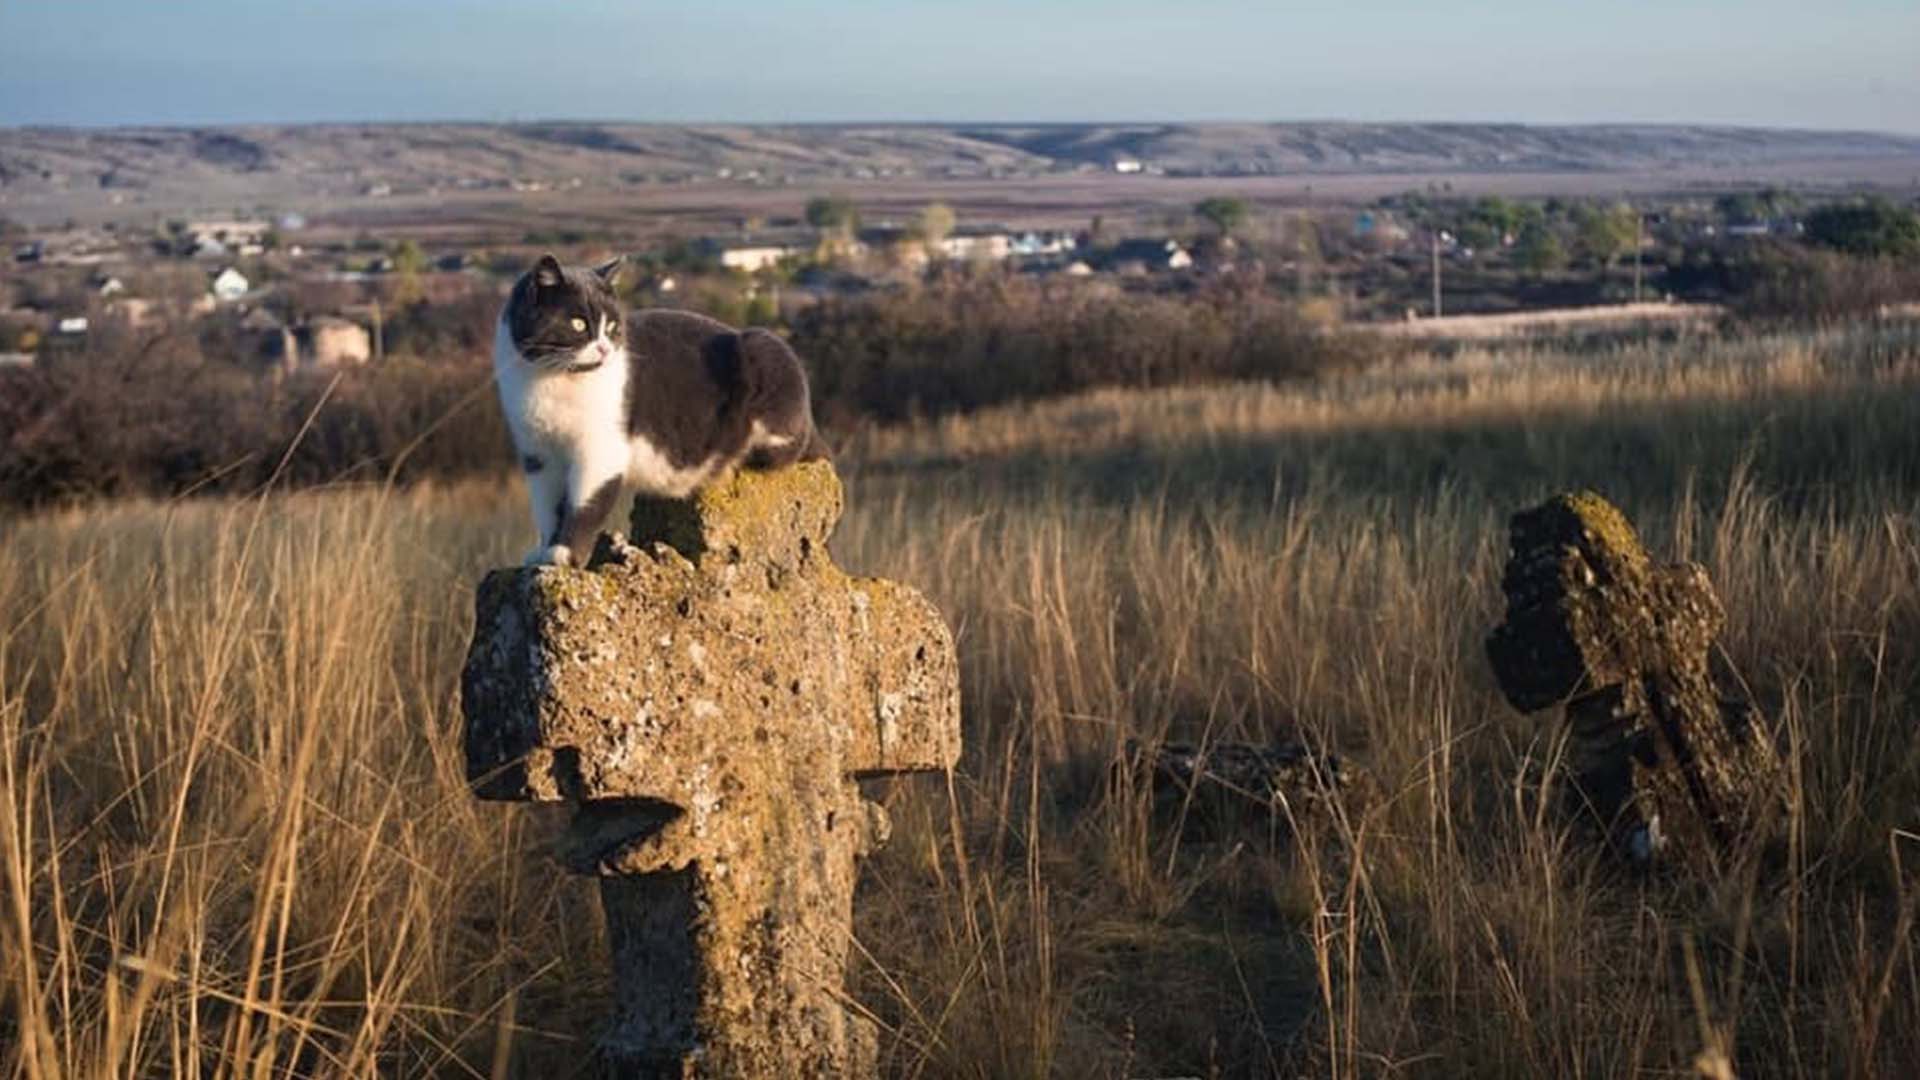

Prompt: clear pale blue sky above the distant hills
[{"left": 0, "top": 0, "right": 1920, "bottom": 133}]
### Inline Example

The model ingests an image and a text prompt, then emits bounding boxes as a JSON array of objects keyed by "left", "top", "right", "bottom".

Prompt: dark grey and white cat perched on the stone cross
[{"left": 493, "top": 254, "right": 828, "bottom": 567}]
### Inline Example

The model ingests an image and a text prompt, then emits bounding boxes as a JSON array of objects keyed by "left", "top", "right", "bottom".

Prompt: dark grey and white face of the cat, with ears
[{"left": 505, "top": 256, "right": 626, "bottom": 371}]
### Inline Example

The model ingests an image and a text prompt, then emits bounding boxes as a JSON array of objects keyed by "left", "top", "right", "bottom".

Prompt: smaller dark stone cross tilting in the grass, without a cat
[{"left": 1486, "top": 492, "right": 1780, "bottom": 861}]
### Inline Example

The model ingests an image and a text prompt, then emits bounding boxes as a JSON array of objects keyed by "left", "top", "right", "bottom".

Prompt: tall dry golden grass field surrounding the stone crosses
[{"left": 0, "top": 323, "right": 1920, "bottom": 1078}]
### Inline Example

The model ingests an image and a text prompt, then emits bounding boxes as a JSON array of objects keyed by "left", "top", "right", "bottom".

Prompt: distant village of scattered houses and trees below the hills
[{"left": 0, "top": 178, "right": 1873, "bottom": 375}]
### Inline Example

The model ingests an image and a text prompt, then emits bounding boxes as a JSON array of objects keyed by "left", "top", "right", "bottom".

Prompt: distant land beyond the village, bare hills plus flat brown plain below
[{"left": 0, "top": 121, "right": 1920, "bottom": 231}]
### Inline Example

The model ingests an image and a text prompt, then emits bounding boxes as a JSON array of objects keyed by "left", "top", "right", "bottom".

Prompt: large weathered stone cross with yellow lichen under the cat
[{"left": 463, "top": 463, "right": 960, "bottom": 1078}]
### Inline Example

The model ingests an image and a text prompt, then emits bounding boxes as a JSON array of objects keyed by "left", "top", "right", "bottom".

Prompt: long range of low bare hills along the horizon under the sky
[{"left": 0, "top": 123, "right": 1920, "bottom": 211}]
